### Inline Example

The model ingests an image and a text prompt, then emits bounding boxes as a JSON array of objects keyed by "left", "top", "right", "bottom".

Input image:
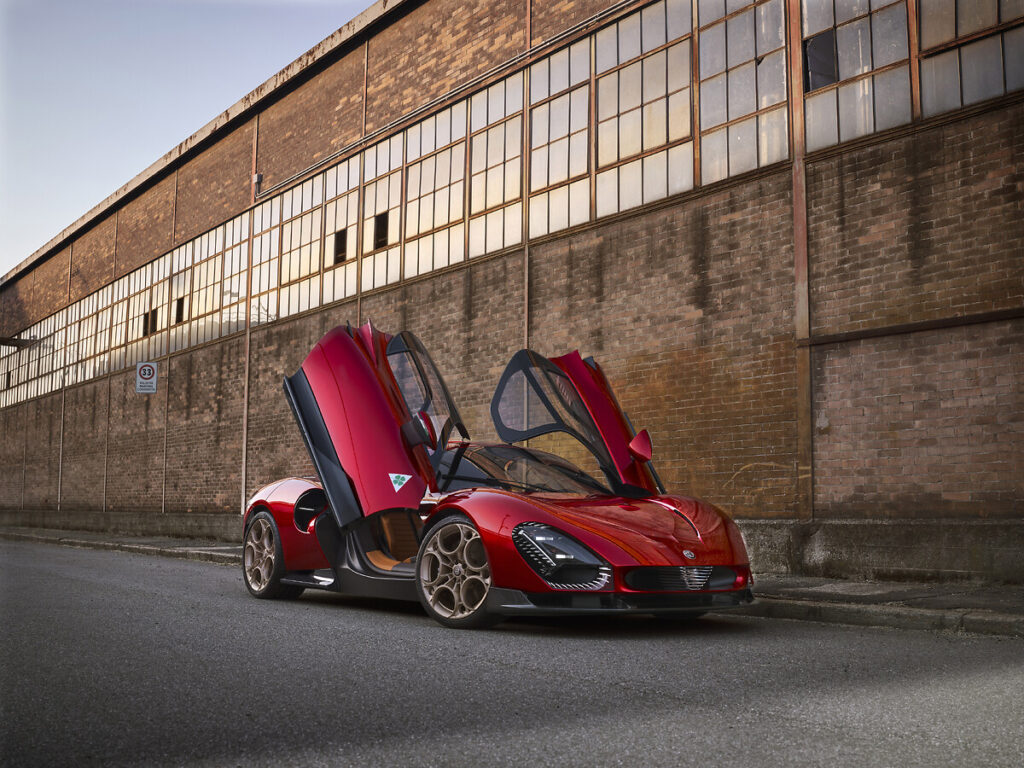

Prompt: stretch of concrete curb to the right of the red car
[{"left": 730, "top": 595, "right": 1024, "bottom": 637}]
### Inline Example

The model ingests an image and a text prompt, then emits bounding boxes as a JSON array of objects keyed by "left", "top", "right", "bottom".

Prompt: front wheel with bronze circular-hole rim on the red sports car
[{"left": 416, "top": 514, "right": 503, "bottom": 630}]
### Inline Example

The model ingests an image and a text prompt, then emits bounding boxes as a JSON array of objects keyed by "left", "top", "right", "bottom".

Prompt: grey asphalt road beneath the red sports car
[{"left": 6, "top": 542, "right": 1024, "bottom": 768}]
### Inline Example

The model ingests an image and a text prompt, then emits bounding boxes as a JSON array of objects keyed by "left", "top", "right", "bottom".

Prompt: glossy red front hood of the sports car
[{"left": 512, "top": 495, "right": 748, "bottom": 565}]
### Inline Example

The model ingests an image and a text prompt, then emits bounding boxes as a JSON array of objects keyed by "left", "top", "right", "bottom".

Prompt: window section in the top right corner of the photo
[{"left": 919, "top": 0, "right": 1024, "bottom": 117}]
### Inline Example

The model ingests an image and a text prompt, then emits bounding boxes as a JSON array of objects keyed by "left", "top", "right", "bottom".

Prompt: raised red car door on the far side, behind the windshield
[{"left": 490, "top": 349, "right": 660, "bottom": 497}]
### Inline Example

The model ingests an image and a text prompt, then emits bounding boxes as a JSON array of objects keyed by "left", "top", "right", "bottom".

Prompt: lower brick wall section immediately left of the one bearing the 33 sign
[{"left": 60, "top": 379, "right": 108, "bottom": 513}]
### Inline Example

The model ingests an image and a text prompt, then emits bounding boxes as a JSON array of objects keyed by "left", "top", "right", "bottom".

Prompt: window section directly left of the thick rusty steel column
[{"left": 697, "top": 0, "right": 790, "bottom": 183}]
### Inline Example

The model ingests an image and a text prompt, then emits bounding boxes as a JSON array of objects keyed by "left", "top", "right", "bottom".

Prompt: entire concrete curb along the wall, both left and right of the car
[{"left": 0, "top": 530, "right": 1024, "bottom": 638}]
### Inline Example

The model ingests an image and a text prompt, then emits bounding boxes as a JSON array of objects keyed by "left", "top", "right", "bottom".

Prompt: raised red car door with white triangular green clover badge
[{"left": 285, "top": 324, "right": 465, "bottom": 527}]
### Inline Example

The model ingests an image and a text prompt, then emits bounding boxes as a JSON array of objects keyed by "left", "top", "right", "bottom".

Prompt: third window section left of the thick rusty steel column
[{"left": 529, "top": 42, "right": 589, "bottom": 238}]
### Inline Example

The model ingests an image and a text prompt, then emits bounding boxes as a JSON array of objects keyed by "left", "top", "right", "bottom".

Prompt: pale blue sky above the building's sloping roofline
[{"left": 0, "top": 0, "right": 373, "bottom": 280}]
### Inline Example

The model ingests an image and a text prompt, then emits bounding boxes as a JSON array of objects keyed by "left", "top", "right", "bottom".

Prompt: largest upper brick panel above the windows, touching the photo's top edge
[{"left": 367, "top": 0, "right": 526, "bottom": 132}]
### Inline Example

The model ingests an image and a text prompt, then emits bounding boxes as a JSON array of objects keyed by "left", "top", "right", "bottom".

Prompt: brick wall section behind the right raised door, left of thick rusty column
[{"left": 529, "top": 173, "right": 797, "bottom": 517}]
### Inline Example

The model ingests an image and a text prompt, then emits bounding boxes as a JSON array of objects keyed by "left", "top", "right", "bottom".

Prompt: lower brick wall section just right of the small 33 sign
[{"left": 167, "top": 335, "right": 246, "bottom": 513}]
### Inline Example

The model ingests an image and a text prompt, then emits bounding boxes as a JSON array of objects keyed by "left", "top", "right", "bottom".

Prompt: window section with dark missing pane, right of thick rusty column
[{"left": 802, "top": 0, "right": 911, "bottom": 152}]
